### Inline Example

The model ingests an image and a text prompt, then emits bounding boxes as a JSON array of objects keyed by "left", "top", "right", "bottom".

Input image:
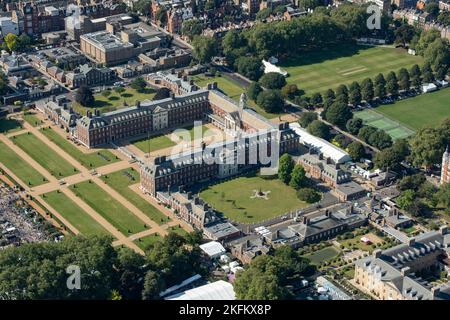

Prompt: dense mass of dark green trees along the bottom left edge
[{"left": 0, "top": 233, "right": 205, "bottom": 300}]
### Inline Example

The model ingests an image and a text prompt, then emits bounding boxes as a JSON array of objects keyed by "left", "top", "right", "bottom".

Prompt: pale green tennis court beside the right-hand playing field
[{"left": 355, "top": 110, "right": 414, "bottom": 140}]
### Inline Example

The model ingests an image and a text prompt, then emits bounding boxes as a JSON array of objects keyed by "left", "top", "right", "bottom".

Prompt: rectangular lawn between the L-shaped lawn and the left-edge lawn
[{"left": 11, "top": 133, "right": 78, "bottom": 178}]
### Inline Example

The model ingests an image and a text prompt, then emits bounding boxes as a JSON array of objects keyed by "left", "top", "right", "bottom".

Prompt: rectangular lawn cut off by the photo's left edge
[{"left": 0, "top": 142, "right": 46, "bottom": 187}]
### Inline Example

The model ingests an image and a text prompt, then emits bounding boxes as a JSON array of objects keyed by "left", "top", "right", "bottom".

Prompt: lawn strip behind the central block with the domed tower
[{"left": 192, "top": 75, "right": 283, "bottom": 119}]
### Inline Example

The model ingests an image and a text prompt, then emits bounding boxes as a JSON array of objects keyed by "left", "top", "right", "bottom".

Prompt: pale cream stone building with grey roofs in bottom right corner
[{"left": 353, "top": 227, "right": 450, "bottom": 300}]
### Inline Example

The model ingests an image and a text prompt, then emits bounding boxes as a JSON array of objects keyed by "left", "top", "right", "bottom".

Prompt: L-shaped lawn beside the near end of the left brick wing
[{"left": 41, "top": 128, "right": 118, "bottom": 169}]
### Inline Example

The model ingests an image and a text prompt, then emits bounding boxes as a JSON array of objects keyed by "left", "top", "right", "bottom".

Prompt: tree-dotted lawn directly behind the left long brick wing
[{"left": 73, "top": 88, "right": 156, "bottom": 115}]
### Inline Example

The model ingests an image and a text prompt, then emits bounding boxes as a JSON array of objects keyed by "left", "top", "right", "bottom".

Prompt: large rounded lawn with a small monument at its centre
[{"left": 200, "top": 175, "right": 307, "bottom": 223}]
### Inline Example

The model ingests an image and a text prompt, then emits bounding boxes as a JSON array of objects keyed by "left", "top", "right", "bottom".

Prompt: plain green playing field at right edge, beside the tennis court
[{"left": 375, "top": 88, "right": 450, "bottom": 130}]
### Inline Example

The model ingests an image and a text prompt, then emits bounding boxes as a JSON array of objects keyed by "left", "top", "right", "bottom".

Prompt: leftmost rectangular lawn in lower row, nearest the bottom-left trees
[{"left": 43, "top": 191, "right": 112, "bottom": 236}]
